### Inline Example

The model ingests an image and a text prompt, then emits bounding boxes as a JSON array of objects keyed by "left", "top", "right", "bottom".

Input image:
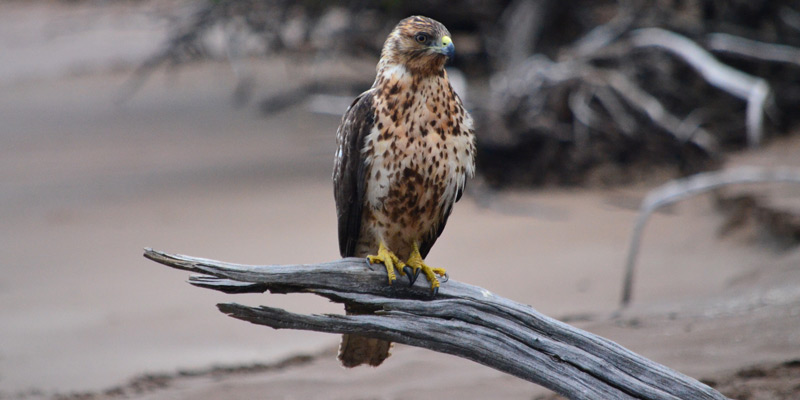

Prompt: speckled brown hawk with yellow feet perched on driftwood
[{"left": 333, "top": 16, "right": 475, "bottom": 367}]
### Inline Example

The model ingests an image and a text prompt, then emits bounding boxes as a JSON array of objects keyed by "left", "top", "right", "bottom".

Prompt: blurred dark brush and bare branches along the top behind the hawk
[{"left": 125, "top": 0, "right": 800, "bottom": 187}]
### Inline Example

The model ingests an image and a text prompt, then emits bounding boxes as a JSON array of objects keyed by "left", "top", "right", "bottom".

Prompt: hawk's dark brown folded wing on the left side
[{"left": 333, "top": 89, "right": 375, "bottom": 257}]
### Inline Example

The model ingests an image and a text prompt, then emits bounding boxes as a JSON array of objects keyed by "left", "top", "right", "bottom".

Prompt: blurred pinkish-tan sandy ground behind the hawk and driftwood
[{"left": 0, "top": 2, "right": 800, "bottom": 400}]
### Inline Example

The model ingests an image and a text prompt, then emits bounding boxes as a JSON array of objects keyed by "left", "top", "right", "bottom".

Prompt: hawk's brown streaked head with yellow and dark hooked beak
[{"left": 380, "top": 16, "right": 455, "bottom": 75}]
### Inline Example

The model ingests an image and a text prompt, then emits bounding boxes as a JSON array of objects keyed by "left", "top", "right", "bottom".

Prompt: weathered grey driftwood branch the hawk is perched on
[{"left": 144, "top": 249, "right": 725, "bottom": 399}]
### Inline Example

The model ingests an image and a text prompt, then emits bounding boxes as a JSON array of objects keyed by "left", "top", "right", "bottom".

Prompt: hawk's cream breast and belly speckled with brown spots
[{"left": 358, "top": 69, "right": 474, "bottom": 258}]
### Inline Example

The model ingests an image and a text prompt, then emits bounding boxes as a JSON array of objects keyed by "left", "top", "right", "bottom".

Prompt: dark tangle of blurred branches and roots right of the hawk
[{"left": 477, "top": 0, "right": 800, "bottom": 186}]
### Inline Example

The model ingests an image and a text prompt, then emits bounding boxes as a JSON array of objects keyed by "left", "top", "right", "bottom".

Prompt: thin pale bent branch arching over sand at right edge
[{"left": 620, "top": 167, "right": 800, "bottom": 307}]
